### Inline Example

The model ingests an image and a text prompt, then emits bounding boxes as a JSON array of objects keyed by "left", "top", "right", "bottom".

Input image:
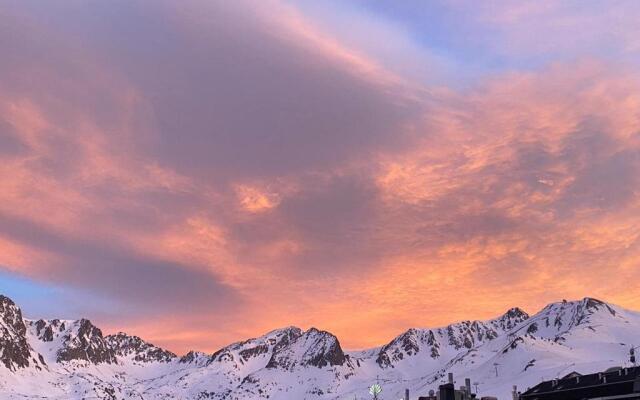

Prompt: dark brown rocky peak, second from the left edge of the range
[{"left": 57, "top": 319, "right": 117, "bottom": 364}]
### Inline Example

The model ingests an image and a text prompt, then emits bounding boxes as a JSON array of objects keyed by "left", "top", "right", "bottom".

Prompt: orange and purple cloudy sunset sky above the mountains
[{"left": 0, "top": 0, "right": 640, "bottom": 353}]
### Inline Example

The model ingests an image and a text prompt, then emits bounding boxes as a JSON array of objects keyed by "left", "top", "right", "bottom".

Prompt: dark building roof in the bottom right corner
[{"left": 520, "top": 367, "right": 640, "bottom": 400}]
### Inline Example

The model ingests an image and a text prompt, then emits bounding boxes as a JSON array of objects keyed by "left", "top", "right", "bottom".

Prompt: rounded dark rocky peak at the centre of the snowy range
[{"left": 267, "top": 328, "right": 349, "bottom": 370}]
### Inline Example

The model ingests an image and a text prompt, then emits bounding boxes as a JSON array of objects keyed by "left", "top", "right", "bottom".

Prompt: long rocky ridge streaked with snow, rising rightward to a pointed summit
[{"left": 376, "top": 308, "right": 529, "bottom": 368}]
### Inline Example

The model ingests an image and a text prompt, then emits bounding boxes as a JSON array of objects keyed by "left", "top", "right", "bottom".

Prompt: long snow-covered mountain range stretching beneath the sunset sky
[{"left": 0, "top": 296, "right": 640, "bottom": 400}]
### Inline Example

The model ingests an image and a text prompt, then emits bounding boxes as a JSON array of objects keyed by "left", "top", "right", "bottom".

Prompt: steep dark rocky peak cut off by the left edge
[{"left": 0, "top": 295, "right": 45, "bottom": 371}]
